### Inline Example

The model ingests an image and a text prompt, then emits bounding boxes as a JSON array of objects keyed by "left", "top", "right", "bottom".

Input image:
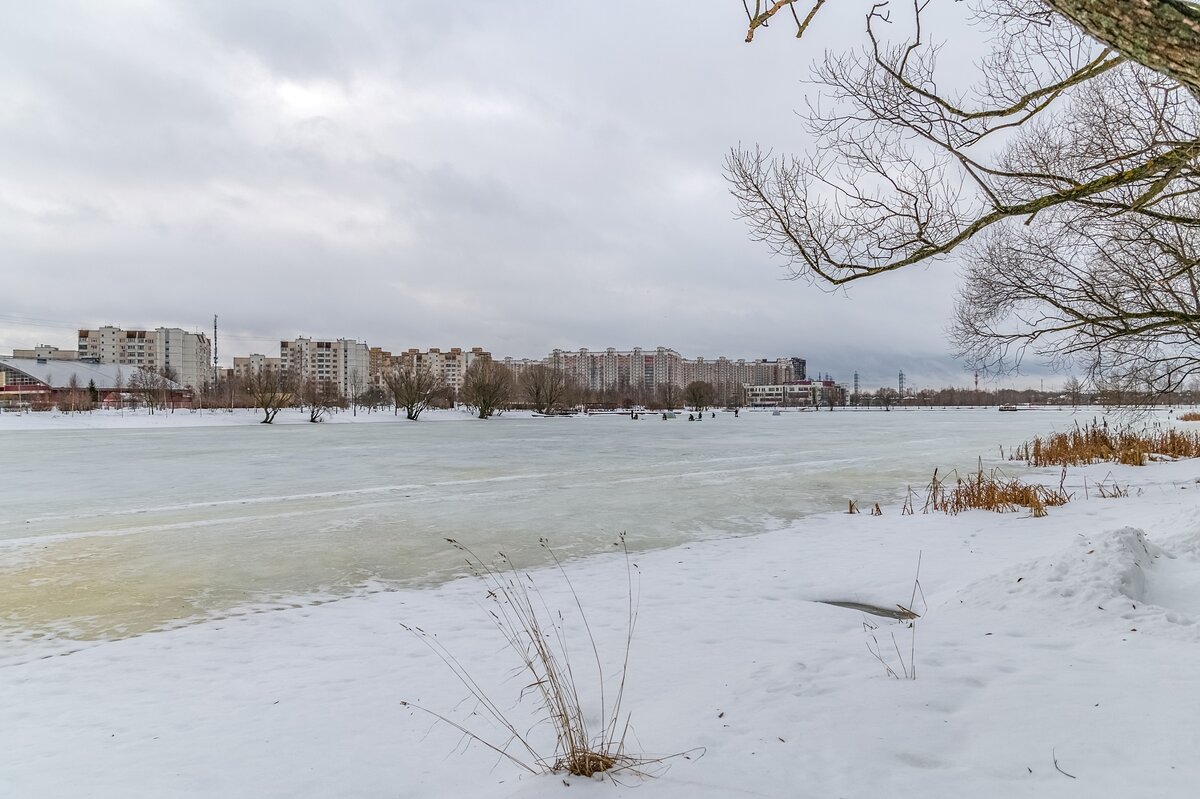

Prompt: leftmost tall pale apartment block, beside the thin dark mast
[{"left": 78, "top": 325, "right": 212, "bottom": 388}]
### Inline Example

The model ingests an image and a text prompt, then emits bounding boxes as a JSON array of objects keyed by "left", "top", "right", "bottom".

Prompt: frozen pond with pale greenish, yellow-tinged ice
[{"left": 0, "top": 409, "right": 1092, "bottom": 641}]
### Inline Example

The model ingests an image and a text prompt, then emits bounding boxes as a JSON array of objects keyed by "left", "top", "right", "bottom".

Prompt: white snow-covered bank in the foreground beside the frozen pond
[{"left": 0, "top": 414, "right": 1200, "bottom": 799}]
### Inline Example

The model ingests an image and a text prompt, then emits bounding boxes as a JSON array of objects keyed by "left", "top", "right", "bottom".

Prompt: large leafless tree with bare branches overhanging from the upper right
[{"left": 727, "top": 0, "right": 1200, "bottom": 391}]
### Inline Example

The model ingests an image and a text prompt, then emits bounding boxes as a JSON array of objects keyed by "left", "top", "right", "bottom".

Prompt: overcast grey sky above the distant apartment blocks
[{"left": 0, "top": 0, "right": 1058, "bottom": 388}]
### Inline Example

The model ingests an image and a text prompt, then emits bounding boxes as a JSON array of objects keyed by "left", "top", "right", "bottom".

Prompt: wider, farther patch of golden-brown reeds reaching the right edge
[{"left": 1012, "top": 421, "right": 1200, "bottom": 467}]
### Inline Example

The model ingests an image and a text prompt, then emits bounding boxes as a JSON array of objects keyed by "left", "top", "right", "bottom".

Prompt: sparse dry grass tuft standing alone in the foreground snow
[{"left": 403, "top": 534, "right": 702, "bottom": 779}]
